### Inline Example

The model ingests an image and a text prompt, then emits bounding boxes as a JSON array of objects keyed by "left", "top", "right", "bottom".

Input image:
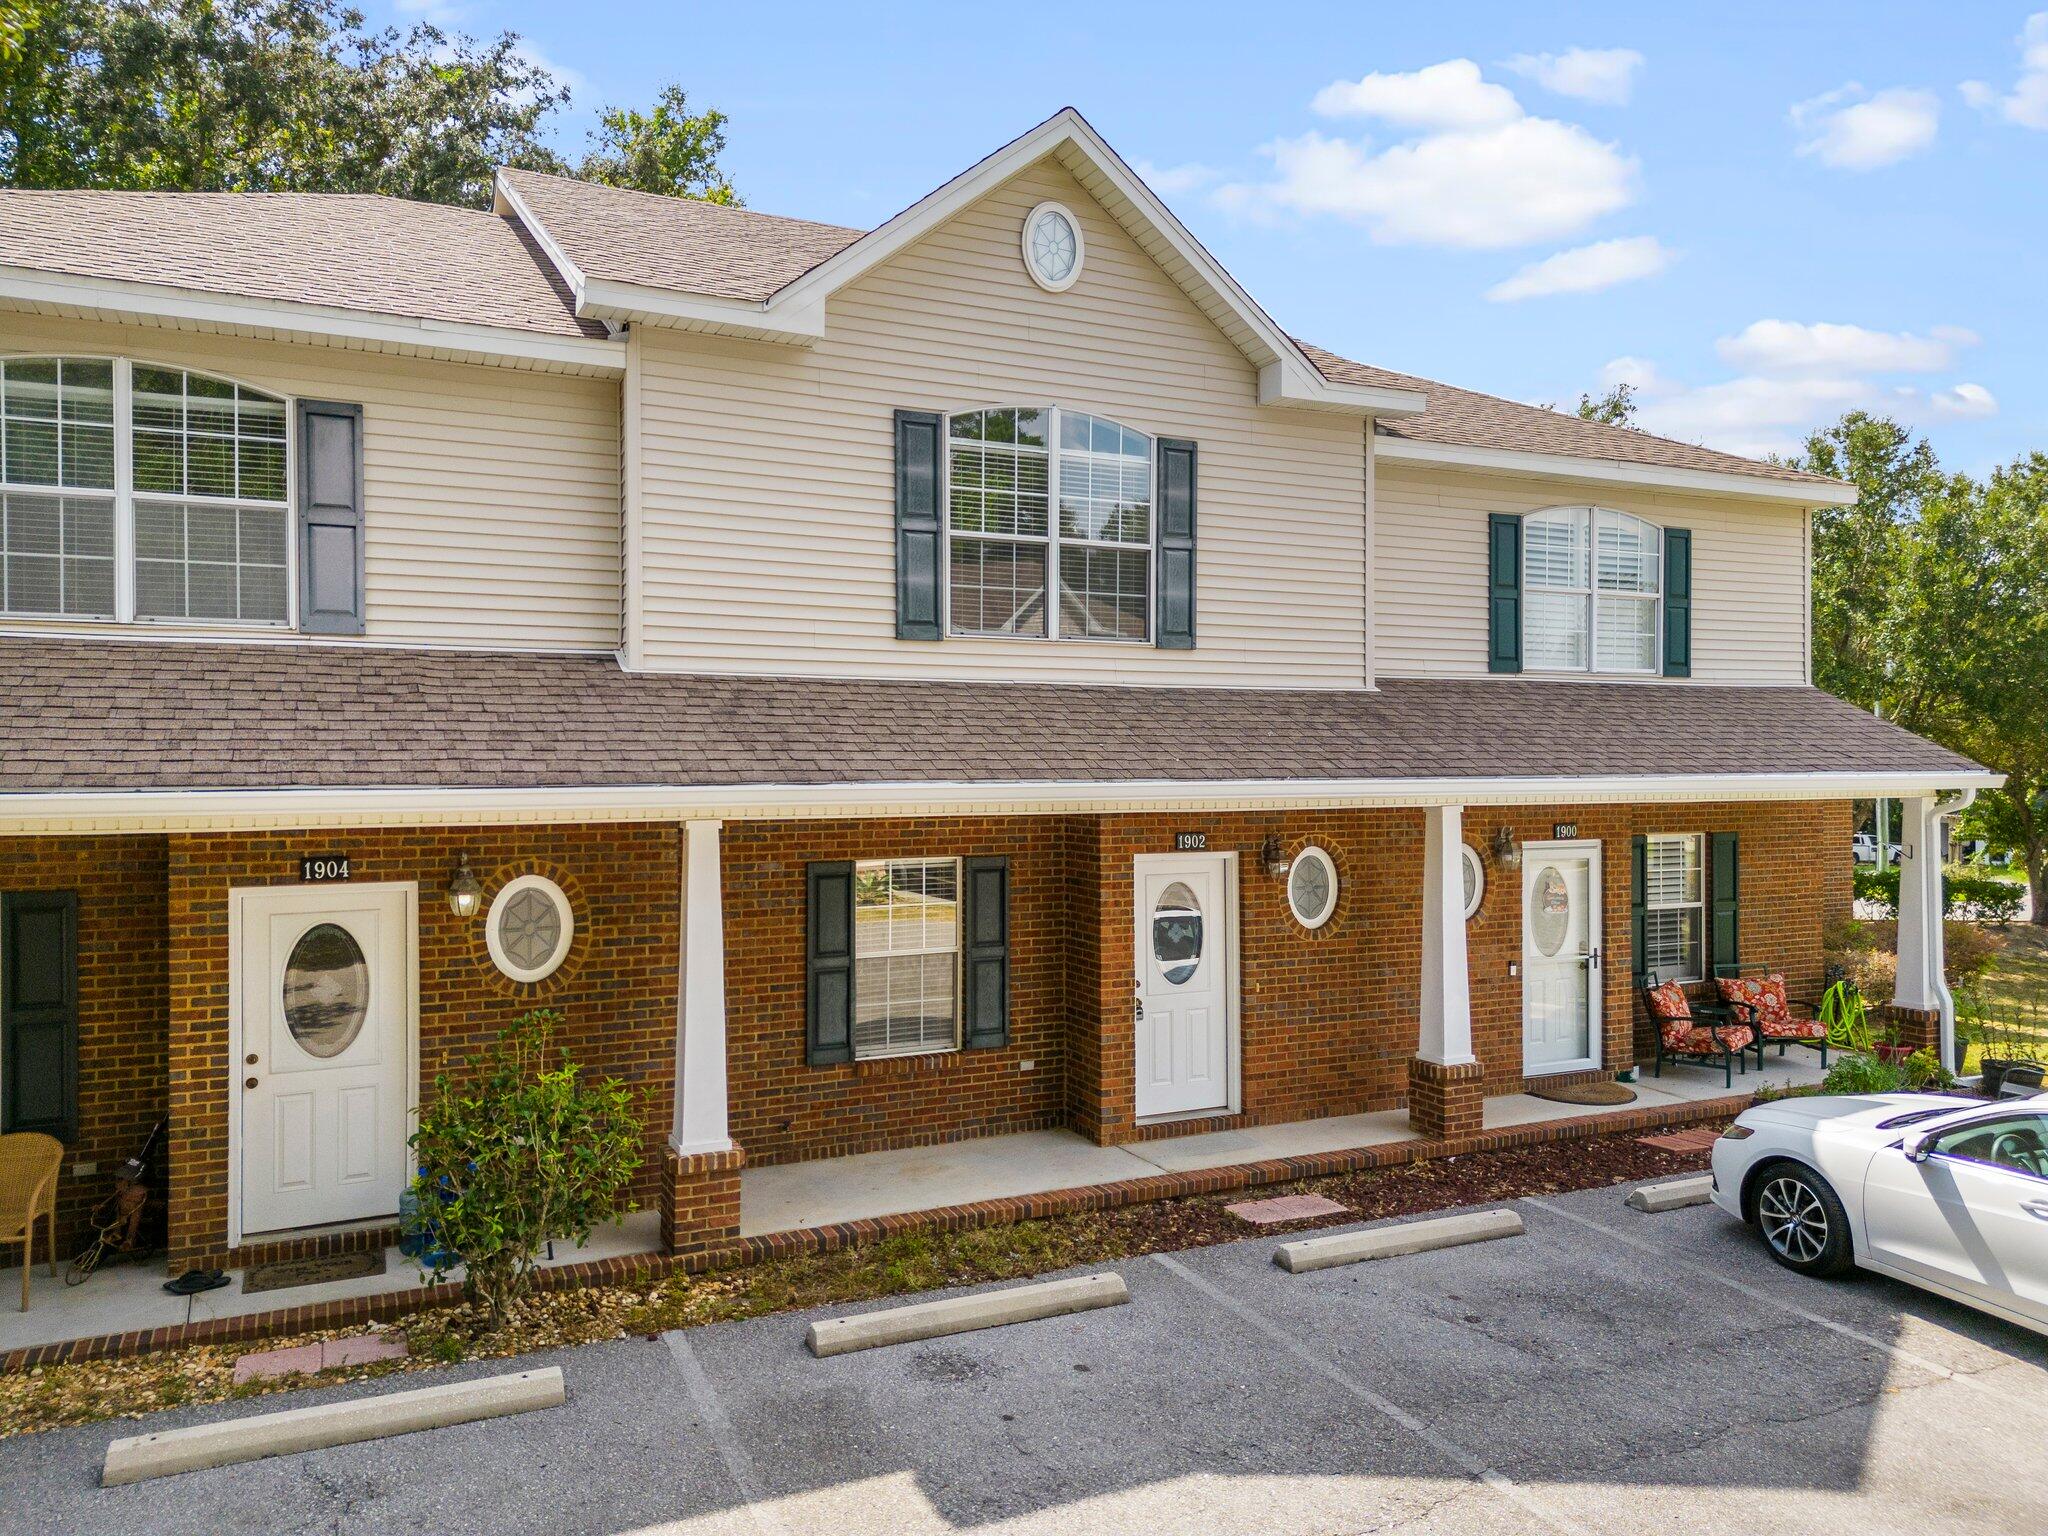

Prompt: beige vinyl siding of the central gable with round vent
[{"left": 629, "top": 162, "right": 1364, "bottom": 684}]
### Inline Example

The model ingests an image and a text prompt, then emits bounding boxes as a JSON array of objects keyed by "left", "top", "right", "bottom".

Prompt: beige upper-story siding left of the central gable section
[{"left": 0, "top": 315, "right": 621, "bottom": 651}]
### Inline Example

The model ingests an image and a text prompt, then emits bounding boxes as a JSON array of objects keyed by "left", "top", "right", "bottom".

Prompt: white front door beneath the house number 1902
[{"left": 1133, "top": 854, "right": 1237, "bottom": 1118}]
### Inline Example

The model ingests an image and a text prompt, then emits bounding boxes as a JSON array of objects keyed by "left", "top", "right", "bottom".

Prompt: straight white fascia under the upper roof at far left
[{"left": 0, "top": 266, "right": 625, "bottom": 373}]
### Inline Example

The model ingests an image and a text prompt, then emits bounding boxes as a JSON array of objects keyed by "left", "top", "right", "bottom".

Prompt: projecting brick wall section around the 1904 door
[{"left": 168, "top": 825, "right": 680, "bottom": 1270}]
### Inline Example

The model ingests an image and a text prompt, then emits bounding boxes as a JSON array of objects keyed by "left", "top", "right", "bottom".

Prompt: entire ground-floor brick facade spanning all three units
[{"left": 0, "top": 803, "right": 1849, "bottom": 1268}]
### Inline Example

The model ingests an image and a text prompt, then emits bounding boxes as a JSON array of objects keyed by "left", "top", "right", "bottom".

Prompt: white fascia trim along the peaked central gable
[{"left": 762, "top": 106, "right": 1427, "bottom": 416}]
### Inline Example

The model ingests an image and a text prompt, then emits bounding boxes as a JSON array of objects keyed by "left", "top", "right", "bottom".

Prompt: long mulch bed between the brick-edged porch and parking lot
[{"left": 0, "top": 1133, "right": 1708, "bottom": 1436}]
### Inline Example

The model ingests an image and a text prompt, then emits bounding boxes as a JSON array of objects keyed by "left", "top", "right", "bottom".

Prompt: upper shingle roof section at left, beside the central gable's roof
[{"left": 0, "top": 188, "right": 606, "bottom": 336}]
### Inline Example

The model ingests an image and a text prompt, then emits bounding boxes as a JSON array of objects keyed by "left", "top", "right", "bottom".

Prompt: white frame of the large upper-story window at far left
[{"left": 0, "top": 348, "right": 299, "bottom": 633}]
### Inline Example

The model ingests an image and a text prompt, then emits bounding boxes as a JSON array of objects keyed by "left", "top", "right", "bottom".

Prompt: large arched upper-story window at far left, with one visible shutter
[{"left": 0, "top": 358, "right": 291, "bottom": 625}]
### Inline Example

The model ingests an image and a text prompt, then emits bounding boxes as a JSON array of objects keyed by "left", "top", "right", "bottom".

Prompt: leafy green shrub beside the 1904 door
[{"left": 408, "top": 1008, "right": 643, "bottom": 1327}]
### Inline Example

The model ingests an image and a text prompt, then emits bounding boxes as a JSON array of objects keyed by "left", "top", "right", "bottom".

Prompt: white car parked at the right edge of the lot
[{"left": 1714, "top": 1094, "right": 2048, "bottom": 1333}]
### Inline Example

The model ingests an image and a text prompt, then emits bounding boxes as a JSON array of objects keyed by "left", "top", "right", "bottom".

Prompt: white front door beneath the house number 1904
[{"left": 229, "top": 885, "right": 418, "bottom": 1235}]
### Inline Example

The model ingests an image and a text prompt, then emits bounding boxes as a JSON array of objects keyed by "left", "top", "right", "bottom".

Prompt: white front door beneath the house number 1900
[{"left": 1522, "top": 842, "right": 1599, "bottom": 1075}]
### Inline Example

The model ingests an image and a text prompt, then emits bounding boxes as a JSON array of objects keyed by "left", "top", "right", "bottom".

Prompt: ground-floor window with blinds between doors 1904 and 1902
[{"left": 854, "top": 858, "right": 961, "bottom": 1061}]
